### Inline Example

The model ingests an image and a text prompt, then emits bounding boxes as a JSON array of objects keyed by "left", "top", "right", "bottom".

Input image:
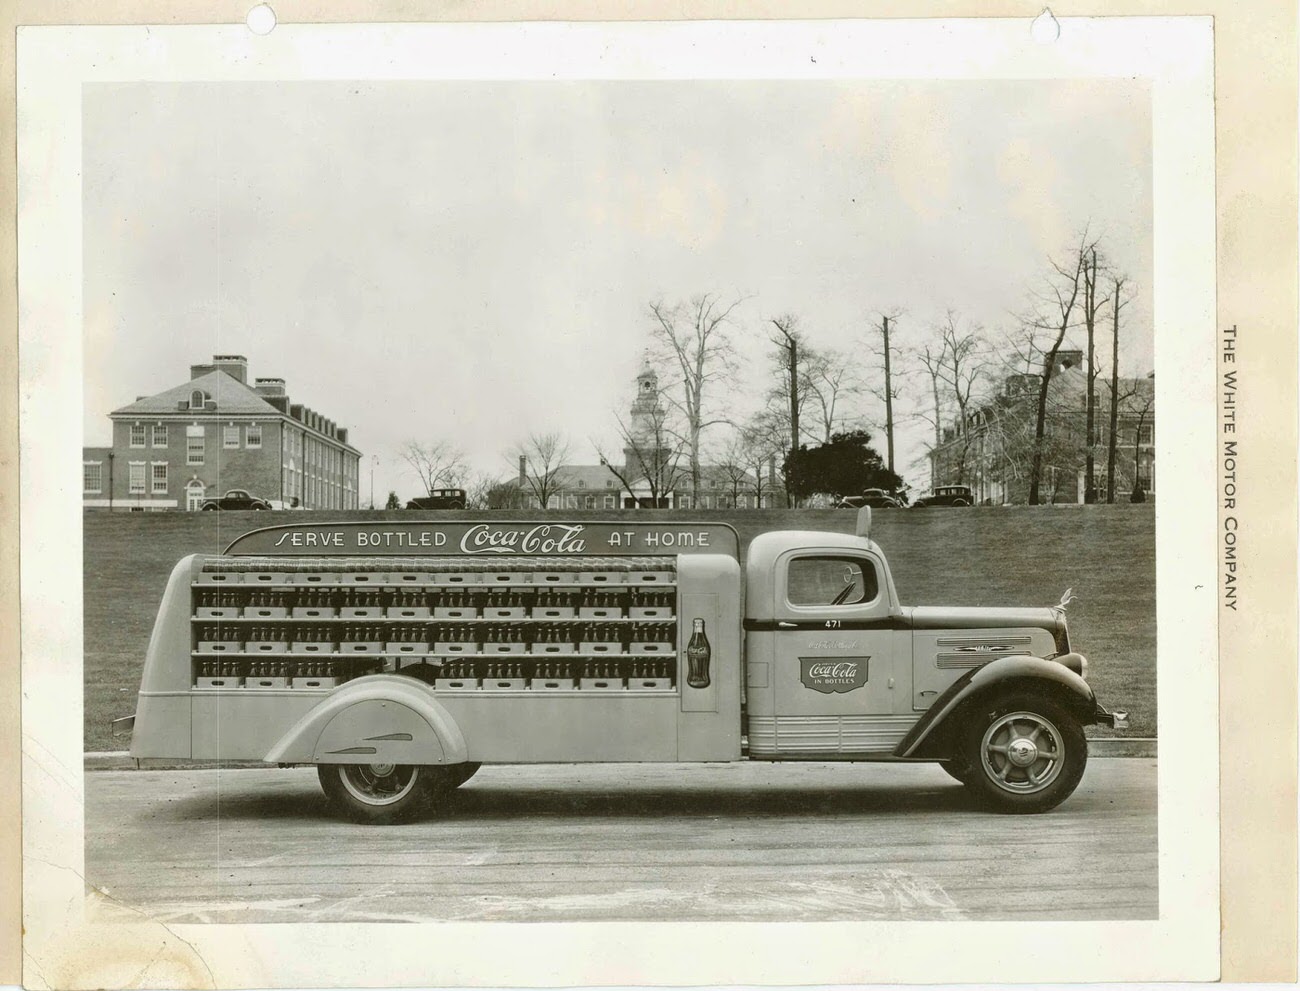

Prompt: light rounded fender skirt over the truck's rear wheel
[{"left": 263, "top": 675, "right": 467, "bottom": 763}]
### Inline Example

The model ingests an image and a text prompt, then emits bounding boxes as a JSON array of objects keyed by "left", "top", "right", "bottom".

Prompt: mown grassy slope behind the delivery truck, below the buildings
[{"left": 83, "top": 505, "right": 1156, "bottom": 750}]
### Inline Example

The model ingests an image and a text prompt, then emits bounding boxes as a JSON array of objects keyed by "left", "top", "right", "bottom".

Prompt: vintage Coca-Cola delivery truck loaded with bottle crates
[{"left": 129, "top": 509, "right": 1127, "bottom": 823}]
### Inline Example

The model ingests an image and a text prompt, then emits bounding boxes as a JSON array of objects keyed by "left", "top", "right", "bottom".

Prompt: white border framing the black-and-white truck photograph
[{"left": 17, "top": 17, "right": 1219, "bottom": 987}]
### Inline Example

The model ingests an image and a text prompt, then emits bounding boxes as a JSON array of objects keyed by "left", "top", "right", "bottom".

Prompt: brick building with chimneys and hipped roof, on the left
[{"left": 82, "top": 355, "right": 361, "bottom": 511}]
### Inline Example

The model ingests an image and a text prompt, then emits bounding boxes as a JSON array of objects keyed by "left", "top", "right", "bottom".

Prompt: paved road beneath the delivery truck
[{"left": 86, "top": 758, "right": 1158, "bottom": 922}]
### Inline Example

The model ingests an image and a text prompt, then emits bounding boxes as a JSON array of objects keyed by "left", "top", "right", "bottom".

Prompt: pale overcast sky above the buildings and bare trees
[{"left": 83, "top": 81, "right": 1153, "bottom": 503}]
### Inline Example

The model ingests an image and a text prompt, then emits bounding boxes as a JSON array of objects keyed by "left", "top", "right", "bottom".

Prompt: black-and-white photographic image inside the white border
[{"left": 15, "top": 14, "right": 1235, "bottom": 986}]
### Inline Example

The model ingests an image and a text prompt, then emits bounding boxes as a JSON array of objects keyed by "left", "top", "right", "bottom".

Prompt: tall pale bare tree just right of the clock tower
[{"left": 650, "top": 293, "right": 741, "bottom": 499}]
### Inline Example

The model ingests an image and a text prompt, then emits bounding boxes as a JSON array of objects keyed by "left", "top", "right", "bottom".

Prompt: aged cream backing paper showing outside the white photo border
[{"left": 0, "top": 0, "right": 1296, "bottom": 983}]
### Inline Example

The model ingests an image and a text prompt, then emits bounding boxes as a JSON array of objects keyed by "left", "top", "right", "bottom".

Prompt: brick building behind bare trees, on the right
[{"left": 930, "top": 350, "right": 1156, "bottom": 506}]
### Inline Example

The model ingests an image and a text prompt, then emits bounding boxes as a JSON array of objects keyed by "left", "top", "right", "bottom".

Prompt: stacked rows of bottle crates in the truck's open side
[{"left": 191, "top": 564, "right": 677, "bottom": 693}]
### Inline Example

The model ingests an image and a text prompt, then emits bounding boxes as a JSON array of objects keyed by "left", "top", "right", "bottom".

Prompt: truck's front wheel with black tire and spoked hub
[{"left": 962, "top": 694, "right": 1088, "bottom": 813}]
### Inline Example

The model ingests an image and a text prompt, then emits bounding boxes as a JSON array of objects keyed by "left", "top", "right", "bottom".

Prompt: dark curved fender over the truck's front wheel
[{"left": 894, "top": 654, "right": 1097, "bottom": 758}]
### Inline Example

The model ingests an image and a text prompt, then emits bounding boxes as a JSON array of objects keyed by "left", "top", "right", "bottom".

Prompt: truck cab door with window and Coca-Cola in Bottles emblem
[{"left": 750, "top": 550, "right": 915, "bottom": 757}]
